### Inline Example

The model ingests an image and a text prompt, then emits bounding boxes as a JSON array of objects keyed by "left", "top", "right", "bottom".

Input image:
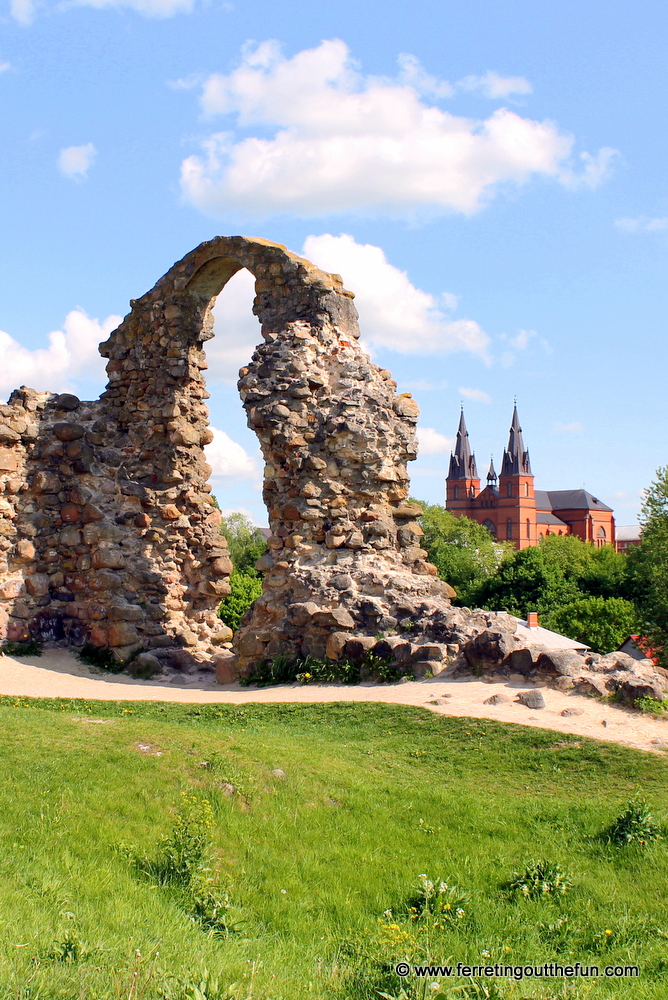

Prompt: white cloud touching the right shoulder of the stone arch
[{"left": 302, "top": 233, "right": 489, "bottom": 358}]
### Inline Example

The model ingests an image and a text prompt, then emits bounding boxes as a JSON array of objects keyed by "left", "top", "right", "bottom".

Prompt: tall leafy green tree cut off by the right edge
[{"left": 628, "top": 466, "right": 668, "bottom": 667}]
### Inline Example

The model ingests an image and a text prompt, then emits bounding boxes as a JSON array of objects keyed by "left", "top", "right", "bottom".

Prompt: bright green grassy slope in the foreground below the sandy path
[{"left": 0, "top": 698, "right": 668, "bottom": 1000}]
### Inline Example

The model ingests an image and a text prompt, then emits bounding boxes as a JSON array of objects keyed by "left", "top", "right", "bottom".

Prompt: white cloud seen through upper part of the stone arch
[{"left": 206, "top": 268, "right": 262, "bottom": 385}]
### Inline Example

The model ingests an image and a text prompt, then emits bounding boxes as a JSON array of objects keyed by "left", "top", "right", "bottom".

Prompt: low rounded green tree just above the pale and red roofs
[{"left": 541, "top": 597, "right": 638, "bottom": 653}]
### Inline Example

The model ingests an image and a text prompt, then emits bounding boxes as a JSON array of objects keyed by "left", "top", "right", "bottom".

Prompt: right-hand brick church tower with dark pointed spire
[{"left": 497, "top": 406, "right": 537, "bottom": 549}]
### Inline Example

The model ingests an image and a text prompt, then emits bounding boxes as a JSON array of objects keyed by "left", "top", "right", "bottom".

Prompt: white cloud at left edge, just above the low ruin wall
[{"left": 0, "top": 309, "right": 121, "bottom": 393}]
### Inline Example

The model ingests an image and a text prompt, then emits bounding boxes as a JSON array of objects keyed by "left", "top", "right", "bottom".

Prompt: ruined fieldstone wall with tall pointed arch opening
[{"left": 0, "top": 237, "right": 664, "bottom": 700}]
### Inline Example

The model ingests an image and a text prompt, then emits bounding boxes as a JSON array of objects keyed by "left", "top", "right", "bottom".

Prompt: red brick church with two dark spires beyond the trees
[{"left": 445, "top": 407, "right": 615, "bottom": 549}]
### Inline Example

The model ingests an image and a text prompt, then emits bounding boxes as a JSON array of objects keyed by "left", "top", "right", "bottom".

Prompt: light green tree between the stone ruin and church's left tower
[{"left": 418, "top": 500, "right": 507, "bottom": 604}]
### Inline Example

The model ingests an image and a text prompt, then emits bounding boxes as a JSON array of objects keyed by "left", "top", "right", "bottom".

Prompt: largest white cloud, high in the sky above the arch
[{"left": 181, "top": 39, "right": 607, "bottom": 217}]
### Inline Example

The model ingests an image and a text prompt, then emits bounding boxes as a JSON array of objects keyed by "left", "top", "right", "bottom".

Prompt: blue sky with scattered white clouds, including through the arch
[{"left": 0, "top": 0, "right": 668, "bottom": 524}]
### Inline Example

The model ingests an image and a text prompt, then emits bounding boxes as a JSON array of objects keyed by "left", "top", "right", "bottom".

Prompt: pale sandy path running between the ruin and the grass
[{"left": 0, "top": 650, "right": 668, "bottom": 753}]
